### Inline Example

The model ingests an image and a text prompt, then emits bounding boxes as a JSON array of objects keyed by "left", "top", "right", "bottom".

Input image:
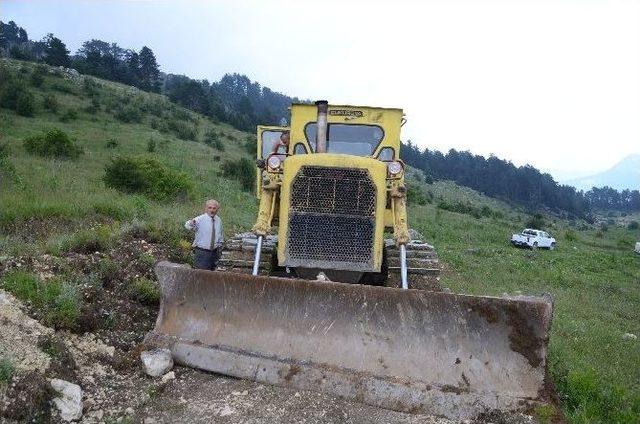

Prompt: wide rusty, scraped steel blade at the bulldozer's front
[{"left": 145, "top": 262, "right": 552, "bottom": 419}]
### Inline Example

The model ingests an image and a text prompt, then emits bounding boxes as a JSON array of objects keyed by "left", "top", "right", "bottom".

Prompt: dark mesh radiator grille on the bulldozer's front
[{"left": 286, "top": 166, "right": 376, "bottom": 270}]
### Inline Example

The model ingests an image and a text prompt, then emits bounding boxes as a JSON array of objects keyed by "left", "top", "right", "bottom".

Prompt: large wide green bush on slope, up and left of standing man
[{"left": 103, "top": 157, "right": 193, "bottom": 200}]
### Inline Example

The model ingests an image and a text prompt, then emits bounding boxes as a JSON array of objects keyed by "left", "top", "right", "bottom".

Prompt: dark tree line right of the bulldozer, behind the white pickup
[{"left": 401, "top": 141, "right": 640, "bottom": 219}]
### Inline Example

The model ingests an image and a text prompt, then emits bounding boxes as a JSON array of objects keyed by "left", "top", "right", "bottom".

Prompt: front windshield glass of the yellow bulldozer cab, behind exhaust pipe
[{"left": 304, "top": 122, "right": 384, "bottom": 156}]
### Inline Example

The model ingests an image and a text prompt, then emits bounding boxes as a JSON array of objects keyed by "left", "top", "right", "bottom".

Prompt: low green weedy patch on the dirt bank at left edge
[{"left": 0, "top": 271, "right": 82, "bottom": 329}]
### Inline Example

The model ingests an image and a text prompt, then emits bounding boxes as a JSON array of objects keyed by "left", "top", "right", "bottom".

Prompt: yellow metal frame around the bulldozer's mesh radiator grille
[{"left": 278, "top": 153, "right": 387, "bottom": 272}]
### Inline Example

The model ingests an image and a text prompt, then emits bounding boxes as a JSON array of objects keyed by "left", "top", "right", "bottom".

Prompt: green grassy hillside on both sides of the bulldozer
[{"left": 0, "top": 60, "right": 640, "bottom": 423}]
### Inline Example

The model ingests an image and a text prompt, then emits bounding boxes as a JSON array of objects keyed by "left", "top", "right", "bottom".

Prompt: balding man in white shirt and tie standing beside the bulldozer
[{"left": 184, "top": 199, "right": 224, "bottom": 271}]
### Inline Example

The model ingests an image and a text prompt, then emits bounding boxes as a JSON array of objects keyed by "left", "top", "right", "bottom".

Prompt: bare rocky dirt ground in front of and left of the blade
[{"left": 0, "top": 237, "right": 533, "bottom": 423}]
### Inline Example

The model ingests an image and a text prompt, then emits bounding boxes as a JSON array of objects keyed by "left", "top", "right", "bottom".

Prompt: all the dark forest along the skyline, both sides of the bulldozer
[{"left": 0, "top": 21, "right": 640, "bottom": 218}]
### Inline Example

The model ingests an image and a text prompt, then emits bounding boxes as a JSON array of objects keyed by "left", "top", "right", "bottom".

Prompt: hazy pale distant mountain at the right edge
[{"left": 566, "top": 154, "right": 640, "bottom": 191}]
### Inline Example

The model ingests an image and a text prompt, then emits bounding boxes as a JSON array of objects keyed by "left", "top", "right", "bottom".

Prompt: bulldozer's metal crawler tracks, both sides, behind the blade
[{"left": 218, "top": 233, "right": 441, "bottom": 291}]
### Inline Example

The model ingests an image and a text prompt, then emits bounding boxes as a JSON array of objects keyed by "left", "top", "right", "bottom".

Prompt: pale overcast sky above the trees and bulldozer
[{"left": 0, "top": 0, "right": 640, "bottom": 177}]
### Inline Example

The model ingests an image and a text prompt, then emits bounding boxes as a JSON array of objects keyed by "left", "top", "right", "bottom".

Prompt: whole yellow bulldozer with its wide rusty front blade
[{"left": 146, "top": 101, "right": 553, "bottom": 419}]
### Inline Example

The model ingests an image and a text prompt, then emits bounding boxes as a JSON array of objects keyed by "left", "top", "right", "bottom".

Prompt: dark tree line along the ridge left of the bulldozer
[{"left": 0, "top": 21, "right": 299, "bottom": 131}]
